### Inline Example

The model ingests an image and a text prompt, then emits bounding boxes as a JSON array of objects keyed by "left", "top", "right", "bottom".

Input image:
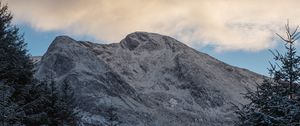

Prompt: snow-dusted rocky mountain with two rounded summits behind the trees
[{"left": 35, "top": 32, "right": 262, "bottom": 126}]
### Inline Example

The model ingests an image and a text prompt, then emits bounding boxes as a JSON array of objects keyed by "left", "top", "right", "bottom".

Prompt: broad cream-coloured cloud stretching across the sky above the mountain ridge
[{"left": 8, "top": 0, "right": 300, "bottom": 51}]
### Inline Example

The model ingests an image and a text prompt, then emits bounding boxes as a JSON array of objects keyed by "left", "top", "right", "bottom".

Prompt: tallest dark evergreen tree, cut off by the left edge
[{"left": 0, "top": 2, "right": 33, "bottom": 125}]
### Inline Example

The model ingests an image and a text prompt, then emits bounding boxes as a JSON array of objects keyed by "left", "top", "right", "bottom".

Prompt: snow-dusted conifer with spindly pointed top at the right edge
[{"left": 236, "top": 23, "right": 300, "bottom": 126}]
